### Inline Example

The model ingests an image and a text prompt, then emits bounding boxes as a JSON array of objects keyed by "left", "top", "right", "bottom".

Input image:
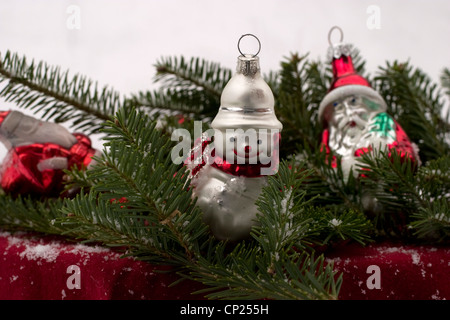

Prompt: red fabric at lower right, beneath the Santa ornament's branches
[{"left": 327, "top": 243, "right": 450, "bottom": 300}]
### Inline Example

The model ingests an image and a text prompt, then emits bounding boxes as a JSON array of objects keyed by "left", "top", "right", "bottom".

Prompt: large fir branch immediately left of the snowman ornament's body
[{"left": 58, "top": 108, "right": 206, "bottom": 263}]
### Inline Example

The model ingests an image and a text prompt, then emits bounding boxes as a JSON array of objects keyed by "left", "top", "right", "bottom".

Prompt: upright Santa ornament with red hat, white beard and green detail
[{"left": 319, "top": 27, "right": 419, "bottom": 180}]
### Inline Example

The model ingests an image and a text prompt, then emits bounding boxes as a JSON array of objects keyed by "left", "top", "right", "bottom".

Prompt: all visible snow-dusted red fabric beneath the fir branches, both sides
[{"left": 0, "top": 232, "right": 450, "bottom": 300}]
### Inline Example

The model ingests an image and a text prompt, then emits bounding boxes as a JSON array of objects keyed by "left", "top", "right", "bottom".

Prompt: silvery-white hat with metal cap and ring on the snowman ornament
[{"left": 211, "top": 34, "right": 283, "bottom": 130}]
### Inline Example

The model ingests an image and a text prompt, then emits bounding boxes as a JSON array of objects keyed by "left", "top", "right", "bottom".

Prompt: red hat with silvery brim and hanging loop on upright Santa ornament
[{"left": 319, "top": 27, "right": 387, "bottom": 124}]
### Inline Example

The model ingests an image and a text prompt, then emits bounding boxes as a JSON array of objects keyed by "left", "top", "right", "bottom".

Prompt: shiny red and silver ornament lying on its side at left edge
[{"left": 0, "top": 111, "right": 99, "bottom": 197}]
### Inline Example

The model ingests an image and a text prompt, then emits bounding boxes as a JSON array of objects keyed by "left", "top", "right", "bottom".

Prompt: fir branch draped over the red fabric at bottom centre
[{"left": 189, "top": 249, "right": 342, "bottom": 300}]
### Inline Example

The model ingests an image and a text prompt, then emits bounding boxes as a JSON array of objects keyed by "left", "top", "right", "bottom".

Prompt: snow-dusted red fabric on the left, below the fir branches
[{"left": 0, "top": 232, "right": 201, "bottom": 300}]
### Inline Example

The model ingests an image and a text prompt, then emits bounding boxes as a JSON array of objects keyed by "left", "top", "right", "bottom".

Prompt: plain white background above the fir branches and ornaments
[{"left": 0, "top": 0, "right": 450, "bottom": 152}]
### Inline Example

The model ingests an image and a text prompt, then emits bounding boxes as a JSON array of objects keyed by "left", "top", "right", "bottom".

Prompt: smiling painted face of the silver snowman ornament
[{"left": 214, "top": 128, "right": 279, "bottom": 164}]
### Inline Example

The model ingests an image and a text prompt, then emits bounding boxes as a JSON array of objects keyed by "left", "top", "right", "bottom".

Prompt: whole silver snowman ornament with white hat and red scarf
[{"left": 187, "top": 34, "right": 282, "bottom": 241}]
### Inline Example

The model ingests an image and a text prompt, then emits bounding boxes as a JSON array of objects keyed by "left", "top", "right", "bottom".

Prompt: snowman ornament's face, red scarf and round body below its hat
[{"left": 192, "top": 128, "right": 280, "bottom": 241}]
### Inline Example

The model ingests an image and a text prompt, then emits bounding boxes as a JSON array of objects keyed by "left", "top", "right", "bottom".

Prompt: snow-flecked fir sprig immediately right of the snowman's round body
[{"left": 253, "top": 162, "right": 372, "bottom": 249}]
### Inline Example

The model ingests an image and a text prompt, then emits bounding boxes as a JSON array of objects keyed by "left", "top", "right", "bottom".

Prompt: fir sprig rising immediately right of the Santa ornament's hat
[{"left": 375, "top": 61, "right": 450, "bottom": 162}]
